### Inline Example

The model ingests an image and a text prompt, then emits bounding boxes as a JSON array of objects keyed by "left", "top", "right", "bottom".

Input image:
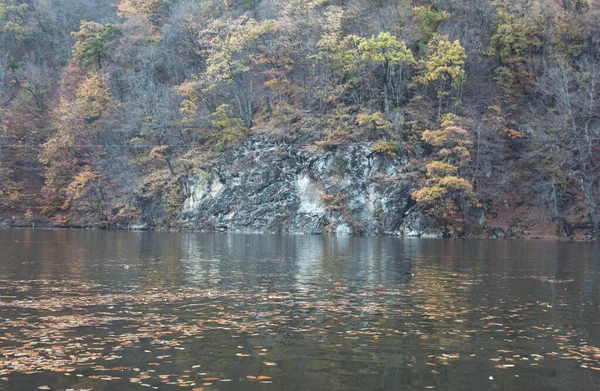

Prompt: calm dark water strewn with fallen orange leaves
[{"left": 0, "top": 230, "right": 600, "bottom": 391}]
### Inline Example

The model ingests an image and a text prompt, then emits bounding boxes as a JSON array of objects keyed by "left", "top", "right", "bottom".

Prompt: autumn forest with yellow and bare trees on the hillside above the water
[{"left": 0, "top": 0, "right": 600, "bottom": 238}]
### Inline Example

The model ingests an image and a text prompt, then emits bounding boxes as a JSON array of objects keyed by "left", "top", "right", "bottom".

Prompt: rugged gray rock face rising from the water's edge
[{"left": 181, "top": 138, "right": 436, "bottom": 234}]
